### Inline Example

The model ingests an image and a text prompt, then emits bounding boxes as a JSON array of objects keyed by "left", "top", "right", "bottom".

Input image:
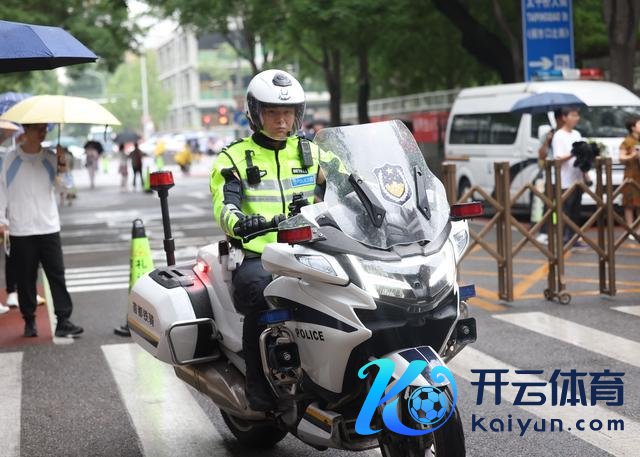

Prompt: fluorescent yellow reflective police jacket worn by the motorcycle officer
[{"left": 210, "top": 134, "right": 319, "bottom": 254}]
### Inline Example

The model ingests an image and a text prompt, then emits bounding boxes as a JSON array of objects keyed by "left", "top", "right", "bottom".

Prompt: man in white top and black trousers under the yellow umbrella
[{"left": 0, "top": 124, "right": 83, "bottom": 337}]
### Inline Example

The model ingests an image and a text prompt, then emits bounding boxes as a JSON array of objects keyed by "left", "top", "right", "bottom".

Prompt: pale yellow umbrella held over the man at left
[{"left": 0, "top": 95, "right": 120, "bottom": 125}]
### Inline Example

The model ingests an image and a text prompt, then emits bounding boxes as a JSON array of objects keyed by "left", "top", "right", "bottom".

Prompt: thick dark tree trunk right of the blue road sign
[{"left": 604, "top": 0, "right": 640, "bottom": 90}]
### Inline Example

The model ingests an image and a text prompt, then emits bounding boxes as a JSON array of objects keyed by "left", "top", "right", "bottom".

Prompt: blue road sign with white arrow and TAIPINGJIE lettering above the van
[{"left": 522, "top": 0, "right": 575, "bottom": 81}]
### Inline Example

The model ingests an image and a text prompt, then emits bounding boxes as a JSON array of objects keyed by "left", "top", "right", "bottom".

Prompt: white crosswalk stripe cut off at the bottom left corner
[{"left": 0, "top": 352, "right": 22, "bottom": 457}]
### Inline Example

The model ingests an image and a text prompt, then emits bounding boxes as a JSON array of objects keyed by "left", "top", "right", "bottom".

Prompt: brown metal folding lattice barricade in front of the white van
[{"left": 443, "top": 157, "right": 640, "bottom": 304}]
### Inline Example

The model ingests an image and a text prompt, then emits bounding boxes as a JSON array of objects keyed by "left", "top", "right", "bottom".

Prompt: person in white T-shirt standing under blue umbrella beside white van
[{"left": 551, "top": 107, "right": 583, "bottom": 247}]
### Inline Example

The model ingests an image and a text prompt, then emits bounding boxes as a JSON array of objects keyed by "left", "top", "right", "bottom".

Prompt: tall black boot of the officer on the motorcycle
[{"left": 242, "top": 312, "right": 276, "bottom": 411}]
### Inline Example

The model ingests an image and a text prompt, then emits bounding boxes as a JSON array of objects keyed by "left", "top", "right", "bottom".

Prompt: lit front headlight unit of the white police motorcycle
[{"left": 347, "top": 243, "right": 456, "bottom": 300}]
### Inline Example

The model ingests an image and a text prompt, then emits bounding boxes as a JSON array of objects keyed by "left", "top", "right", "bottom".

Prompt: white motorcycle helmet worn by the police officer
[{"left": 246, "top": 70, "right": 305, "bottom": 134}]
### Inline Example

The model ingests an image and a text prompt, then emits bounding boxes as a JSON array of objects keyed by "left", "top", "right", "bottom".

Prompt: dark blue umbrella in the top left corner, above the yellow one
[{"left": 0, "top": 21, "right": 98, "bottom": 73}]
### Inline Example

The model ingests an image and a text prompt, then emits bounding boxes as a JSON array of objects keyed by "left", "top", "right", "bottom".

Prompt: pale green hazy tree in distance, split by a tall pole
[{"left": 105, "top": 52, "right": 171, "bottom": 133}]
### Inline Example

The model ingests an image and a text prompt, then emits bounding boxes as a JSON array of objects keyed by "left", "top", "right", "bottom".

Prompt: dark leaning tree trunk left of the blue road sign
[{"left": 433, "top": 0, "right": 522, "bottom": 83}]
